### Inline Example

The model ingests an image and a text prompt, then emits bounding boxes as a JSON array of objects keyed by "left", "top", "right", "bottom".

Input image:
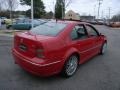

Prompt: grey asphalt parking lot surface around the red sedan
[{"left": 0, "top": 26, "right": 120, "bottom": 90}]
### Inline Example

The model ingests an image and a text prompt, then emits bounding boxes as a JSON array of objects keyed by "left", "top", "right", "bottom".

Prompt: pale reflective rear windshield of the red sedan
[{"left": 30, "top": 22, "right": 67, "bottom": 36}]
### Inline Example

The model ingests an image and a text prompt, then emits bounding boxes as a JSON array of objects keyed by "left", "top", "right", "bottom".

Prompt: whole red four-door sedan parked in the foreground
[{"left": 12, "top": 21, "right": 107, "bottom": 77}]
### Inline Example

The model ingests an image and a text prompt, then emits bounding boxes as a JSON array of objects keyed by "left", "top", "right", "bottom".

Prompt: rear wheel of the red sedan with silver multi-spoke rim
[{"left": 62, "top": 55, "right": 78, "bottom": 78}]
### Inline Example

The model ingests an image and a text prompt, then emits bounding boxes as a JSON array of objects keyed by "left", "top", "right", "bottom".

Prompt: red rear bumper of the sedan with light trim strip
[{"left": 12, "top": 49, "right": 64, "bottom": 76}]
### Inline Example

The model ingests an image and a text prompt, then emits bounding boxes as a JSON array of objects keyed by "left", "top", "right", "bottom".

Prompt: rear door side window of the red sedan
[{"left": 71, "top": 25, "right": 87, "bottom": 40}]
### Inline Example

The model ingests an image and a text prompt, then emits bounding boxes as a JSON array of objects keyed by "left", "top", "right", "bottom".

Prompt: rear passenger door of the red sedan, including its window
[{"left": 71, "top": 24, "right": 94, "bottom": 63}]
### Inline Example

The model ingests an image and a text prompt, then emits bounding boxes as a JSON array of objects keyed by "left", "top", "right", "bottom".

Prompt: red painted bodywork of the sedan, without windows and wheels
[{"left": 12, "top": 21, "right": 107, "bottom": 76}]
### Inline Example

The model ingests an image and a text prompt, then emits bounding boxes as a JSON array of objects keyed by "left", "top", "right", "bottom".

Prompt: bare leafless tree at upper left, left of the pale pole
[{"left": 6, "top": 0, "right": 18, "bottom": 20}]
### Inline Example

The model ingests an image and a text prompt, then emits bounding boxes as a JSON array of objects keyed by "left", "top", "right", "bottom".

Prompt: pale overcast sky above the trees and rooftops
[{"left": 17, "top": 0, "right": 120, "bottom": 17}]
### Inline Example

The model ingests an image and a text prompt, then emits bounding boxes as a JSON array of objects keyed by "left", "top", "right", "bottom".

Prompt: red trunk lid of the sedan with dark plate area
[{"left": 14, "top": 32, "right": 38, "bottom": 57}]
